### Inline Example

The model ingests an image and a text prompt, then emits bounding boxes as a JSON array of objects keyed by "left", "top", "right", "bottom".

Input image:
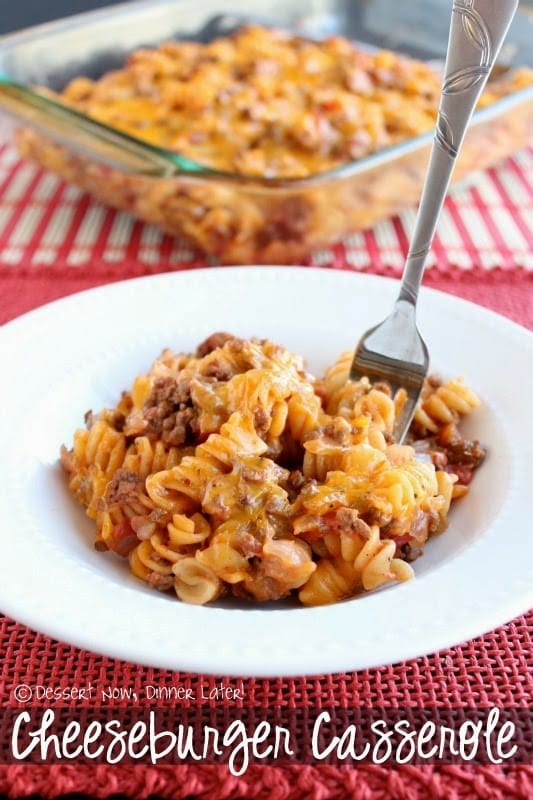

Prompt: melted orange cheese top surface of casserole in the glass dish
[{"left": 53, "top": 25, "right": 533, "bottom": 178}]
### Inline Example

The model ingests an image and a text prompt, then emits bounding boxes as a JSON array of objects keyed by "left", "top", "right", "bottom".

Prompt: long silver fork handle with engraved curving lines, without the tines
[{"left": 398, "top": 0, "right": 518, "bottom": 305}]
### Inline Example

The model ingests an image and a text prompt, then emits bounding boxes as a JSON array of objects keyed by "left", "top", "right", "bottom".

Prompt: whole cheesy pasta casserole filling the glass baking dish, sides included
[{"left": 17, "top": 25, "right": 533, "bottom": 264}]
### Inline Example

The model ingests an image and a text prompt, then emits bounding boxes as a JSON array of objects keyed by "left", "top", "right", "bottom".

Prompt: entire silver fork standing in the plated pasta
[{"left": 350, "top": 0, "right": 518, "bottom": 442}]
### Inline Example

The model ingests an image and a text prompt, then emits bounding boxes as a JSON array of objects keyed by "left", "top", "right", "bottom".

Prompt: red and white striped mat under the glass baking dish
[{"left": 0, "top": 145, "right": 533, "bottom": 275}]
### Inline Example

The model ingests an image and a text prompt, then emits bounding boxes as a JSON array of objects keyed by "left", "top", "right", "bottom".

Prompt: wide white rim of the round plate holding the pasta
[{"left": 0, "top": 266, "right": 533, "bottom": 677}]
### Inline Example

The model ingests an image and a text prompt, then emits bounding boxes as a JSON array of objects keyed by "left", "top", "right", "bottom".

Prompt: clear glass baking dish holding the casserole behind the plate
[{"left": 0, "top": 0, "right": 533, "bottom": 264}]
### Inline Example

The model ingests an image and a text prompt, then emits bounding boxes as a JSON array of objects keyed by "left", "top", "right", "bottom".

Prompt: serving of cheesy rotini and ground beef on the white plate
[{"left": 61, "top": 333, "right": 485, "bottom": 605}]
